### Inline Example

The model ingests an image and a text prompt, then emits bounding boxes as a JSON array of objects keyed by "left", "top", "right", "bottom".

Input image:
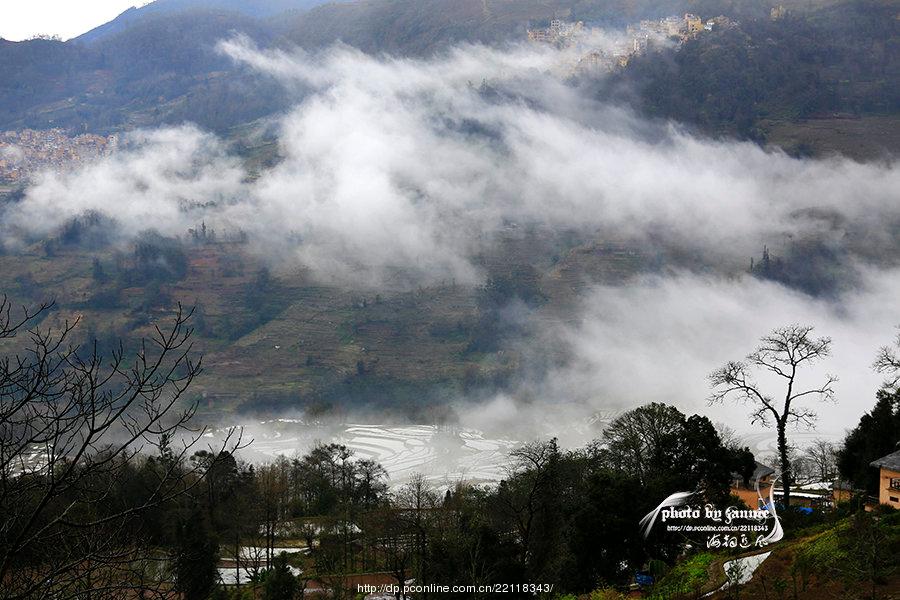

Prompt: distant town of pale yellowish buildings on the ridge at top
[{"left": 528, "top": 13, "right": 735, "bottom": 76}]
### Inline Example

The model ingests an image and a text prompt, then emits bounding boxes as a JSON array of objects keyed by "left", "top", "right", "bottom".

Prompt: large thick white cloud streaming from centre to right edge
[{"left": 216, "top": 40, "right": 900, "bottom": 280}]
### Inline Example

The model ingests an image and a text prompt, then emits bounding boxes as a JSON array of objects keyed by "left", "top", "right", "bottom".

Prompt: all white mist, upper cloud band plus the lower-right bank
[{"left": 2, "top": 34, "right": 900, "bottom": 460}]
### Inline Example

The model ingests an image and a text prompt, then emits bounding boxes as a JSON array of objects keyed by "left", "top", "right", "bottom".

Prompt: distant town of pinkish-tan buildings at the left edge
[{"left": 0, "top": 129, "right": 119, "bottom": 183}]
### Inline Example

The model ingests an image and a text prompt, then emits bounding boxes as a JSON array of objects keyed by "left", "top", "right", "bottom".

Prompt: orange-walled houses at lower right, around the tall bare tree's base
[{"left": 731, "top": 450, "right": 900, "bottom": 510}]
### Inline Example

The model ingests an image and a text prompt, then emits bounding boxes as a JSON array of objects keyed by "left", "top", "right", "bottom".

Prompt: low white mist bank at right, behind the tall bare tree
[{"left": 486, "top": 269, "right": 900, "bottom": 437}]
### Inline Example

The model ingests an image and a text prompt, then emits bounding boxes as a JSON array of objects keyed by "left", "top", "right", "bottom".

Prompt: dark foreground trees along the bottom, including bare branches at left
[{"left": 0, "top": 296, "right": 900, "bottom": 600}]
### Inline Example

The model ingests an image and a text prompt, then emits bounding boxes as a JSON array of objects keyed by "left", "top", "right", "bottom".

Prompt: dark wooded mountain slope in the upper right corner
[{"left": 616, "top": 1, "right": 900, "bottom": 140}]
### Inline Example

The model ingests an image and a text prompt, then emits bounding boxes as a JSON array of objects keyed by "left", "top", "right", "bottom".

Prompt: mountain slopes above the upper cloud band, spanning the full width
[{"left": 0, "top": 0, "right": 900, "bottom": 156}]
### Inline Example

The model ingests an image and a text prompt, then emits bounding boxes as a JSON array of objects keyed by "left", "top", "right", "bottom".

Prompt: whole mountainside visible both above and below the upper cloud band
[{"left": 0, "top": 0, "right": 900, "bottom": 422}]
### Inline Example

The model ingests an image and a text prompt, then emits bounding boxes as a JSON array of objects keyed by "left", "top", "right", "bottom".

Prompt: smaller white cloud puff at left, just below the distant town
[{"left": 2, "top": 126, "right": 244, "bottom": 245}]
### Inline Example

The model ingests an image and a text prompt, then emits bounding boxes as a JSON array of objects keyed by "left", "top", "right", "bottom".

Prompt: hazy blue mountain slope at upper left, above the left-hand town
[{"left": 0, "top": 9, "right": 281, "bottom": 132}]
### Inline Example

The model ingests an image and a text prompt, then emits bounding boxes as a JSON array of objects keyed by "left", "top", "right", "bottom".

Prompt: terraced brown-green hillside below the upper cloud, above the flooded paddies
[{"left": 0, "top": 216, "right": 647, "bottom": 418}]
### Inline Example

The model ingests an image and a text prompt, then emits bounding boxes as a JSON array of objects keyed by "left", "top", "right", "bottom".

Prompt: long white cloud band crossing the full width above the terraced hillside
[{"left": 4, "top": 38, "right": 900, "bottom": 287}]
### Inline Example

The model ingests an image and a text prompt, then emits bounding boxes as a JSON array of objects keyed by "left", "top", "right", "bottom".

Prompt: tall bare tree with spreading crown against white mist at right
[{"left": 709, "top": 325, "right": 837, "bottom": 506}]
